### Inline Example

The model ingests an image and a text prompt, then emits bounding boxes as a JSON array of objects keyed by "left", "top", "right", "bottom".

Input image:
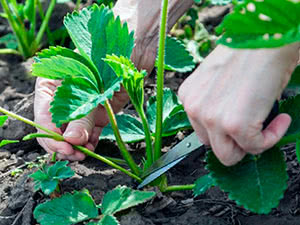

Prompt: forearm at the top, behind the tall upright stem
[{"left": 114, "top": 0, "right": 193, "bottom": 72}]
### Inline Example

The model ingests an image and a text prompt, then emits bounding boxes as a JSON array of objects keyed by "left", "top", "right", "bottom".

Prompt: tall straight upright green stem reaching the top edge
[{"left": 154, "top": 0, "right": 168, "bottom": 161}]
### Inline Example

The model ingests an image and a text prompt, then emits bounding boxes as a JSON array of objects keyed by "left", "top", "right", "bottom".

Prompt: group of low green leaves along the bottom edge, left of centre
[{"left": 34, "top": 186, "right": 155, "bottom": 225}]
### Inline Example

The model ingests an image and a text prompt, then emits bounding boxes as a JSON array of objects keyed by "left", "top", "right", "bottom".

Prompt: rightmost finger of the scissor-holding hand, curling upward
[{"left": 233, "top": 113, "right": 291, "bottom": 154}]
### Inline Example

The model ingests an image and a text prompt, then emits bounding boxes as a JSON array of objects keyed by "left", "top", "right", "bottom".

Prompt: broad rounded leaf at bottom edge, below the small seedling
[{"left": 33, "top": 191, "right": 98, "bottom": 225}]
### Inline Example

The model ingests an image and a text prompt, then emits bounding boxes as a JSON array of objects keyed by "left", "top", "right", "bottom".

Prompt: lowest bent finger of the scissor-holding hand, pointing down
[{"left": 208, "top": 130, "right": 246, "bottom": 166}]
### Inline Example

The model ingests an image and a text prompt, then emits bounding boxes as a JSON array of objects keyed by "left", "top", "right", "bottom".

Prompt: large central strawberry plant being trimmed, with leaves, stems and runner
[{"left": 0, "top": 0, "right": 300, "bottom": 217}]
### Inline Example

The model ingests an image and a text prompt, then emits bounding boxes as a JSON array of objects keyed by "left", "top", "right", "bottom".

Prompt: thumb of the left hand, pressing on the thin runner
[{"left": 63, "top": 110, "right": 95, "bottom": 145}]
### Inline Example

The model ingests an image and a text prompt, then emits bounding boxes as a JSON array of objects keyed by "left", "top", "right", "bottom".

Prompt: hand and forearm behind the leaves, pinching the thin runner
[{"left": 34, "top": 0, "right": 193, "bottom": 160}]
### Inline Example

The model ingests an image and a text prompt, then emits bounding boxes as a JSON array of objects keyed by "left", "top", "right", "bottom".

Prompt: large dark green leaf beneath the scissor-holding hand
[{"left": 206, "top": 147, "right": 288, "bottom": 214}]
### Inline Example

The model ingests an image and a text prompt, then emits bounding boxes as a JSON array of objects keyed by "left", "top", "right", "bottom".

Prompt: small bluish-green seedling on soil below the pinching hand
[{"left": 29, "top": 161, "right": 74, "bottom": 195}]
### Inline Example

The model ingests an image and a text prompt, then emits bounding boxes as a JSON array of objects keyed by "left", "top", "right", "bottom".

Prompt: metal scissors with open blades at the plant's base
[{"left": 138, "top": 100, "right": 279, "bottom": 189}]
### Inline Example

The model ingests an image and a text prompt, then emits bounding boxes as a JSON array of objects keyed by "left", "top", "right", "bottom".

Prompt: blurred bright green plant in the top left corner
[{"left": 0, "top": 0, "right": 56, "bottom": 58}]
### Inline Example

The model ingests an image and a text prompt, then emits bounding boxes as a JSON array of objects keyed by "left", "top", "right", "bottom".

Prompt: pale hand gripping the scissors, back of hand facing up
[{"left": 179, "top": 43, "right": 300, "bottom": 166}]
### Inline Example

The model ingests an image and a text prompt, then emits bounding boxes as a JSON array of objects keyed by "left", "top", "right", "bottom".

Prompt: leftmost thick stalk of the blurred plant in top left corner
[{"left": 0, "top": 0, "right": 29, "bottom": 58}]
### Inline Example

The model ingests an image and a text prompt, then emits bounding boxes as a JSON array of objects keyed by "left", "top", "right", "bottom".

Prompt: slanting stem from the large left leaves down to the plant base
[{"left": 104, "top": 100, "right": 140, "bottom": 175}]
